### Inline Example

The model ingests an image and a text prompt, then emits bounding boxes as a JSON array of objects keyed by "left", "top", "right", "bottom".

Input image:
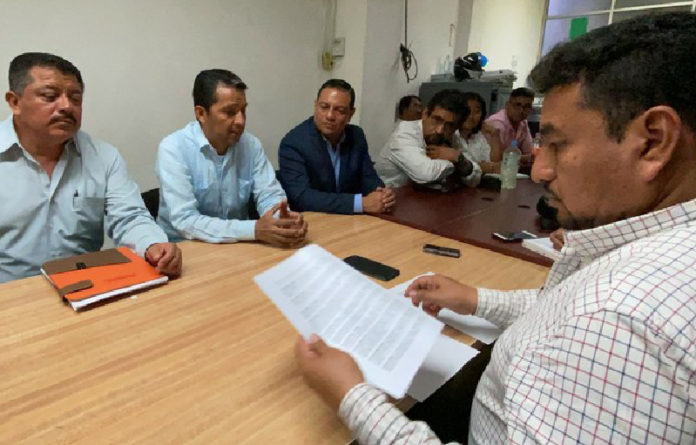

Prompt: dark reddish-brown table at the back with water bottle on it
[{"left": 380, "top": 179, "right": 551, "bottom": 266}]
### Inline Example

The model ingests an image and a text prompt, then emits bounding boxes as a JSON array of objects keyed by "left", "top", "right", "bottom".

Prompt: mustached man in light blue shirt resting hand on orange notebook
[{"left": 0, "top": 53, "right": 181, "bottom": 282}]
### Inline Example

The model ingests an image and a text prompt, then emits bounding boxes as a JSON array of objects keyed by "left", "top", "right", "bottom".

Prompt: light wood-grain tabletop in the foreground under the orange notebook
[{"left": 0, "top": 213, "right": 547, "bottom": 444}]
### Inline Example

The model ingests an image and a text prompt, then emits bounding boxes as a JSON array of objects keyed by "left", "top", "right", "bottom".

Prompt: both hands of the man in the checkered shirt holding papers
[{"left": 295, "top": 275, "right": 478, "bottom": 411}]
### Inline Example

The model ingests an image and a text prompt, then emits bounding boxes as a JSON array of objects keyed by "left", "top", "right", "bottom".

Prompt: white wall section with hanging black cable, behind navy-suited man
[{"left": 332, "top": 0, "right": 459, "bottom": 157}]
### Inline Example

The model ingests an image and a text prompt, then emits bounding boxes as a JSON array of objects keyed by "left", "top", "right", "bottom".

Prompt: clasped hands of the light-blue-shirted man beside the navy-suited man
[{"left": 254, "top": 200, "right": 307, "bottom": 247}]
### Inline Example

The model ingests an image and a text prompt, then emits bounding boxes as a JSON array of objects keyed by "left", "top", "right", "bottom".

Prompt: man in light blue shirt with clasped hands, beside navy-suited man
[{"left": 157, "top": 69, "right": 307, "bottom": 247}]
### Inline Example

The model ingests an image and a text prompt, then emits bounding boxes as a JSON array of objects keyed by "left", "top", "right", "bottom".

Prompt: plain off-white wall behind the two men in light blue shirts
[{"left": 0, "top": 0, "right": 327, "bottom": 189}]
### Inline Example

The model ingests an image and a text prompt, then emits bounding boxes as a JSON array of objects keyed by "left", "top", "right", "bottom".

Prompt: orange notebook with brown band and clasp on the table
[{"left": 41, "top": 247, "right": 167, "bottom": 310}]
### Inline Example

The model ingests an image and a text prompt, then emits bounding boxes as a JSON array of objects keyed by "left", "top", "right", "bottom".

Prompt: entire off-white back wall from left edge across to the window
[{"left": 0, "top": 0, "right": 544, "bottom": 189}]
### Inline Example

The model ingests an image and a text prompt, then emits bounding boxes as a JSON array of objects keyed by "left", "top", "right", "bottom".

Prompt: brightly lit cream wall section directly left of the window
[{"left": 469, "top": 0, "right": 545, "bottom": 87}]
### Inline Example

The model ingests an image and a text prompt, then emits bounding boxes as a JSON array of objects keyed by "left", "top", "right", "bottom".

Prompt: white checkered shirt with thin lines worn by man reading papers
[{"left": 339, "top": 201, "right": 696, "bottom": 444}]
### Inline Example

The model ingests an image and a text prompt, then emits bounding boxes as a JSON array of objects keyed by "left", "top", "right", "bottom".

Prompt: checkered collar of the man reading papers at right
[{"left": 564, "top": 199, "right": 696, "bottom": 259}]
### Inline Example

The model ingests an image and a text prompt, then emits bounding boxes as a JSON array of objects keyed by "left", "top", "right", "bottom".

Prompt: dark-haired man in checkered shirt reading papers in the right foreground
[{"left": 296, "top": 13, "right": 696, "bottom": 444}]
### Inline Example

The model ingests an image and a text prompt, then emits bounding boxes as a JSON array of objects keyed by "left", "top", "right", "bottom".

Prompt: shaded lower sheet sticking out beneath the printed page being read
[{"left": 408, "top": 334, "right": 478, "bottom": 402}]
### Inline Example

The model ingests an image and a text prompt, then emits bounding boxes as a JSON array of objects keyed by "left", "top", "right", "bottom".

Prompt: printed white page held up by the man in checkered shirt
[{"left": 254, "top": 244, "right": 443, "bottom": 398}]
